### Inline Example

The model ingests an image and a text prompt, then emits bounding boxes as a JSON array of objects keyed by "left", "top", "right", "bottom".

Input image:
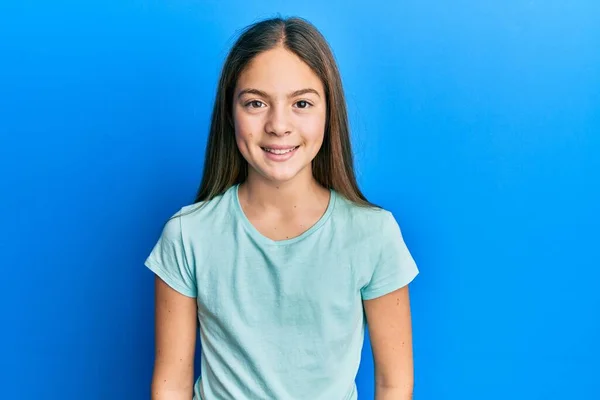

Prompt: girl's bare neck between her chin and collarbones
[{"left": 240, "top": 171, "right": 329, "bottom": 213}]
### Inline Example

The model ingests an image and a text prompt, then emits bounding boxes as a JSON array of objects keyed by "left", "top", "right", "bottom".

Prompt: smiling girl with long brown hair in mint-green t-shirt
[{"left": 145, "top": 18, "right": 418, "bottom": 400}]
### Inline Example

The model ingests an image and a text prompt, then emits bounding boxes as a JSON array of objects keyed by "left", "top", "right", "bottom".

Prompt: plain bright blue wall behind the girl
[{"left": 0, "top": 0, "right": 600, "bottom": 400}]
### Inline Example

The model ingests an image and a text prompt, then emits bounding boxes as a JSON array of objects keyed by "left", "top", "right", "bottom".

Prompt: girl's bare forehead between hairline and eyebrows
[{"left": 237, "top": 47, "right": 323, "bottom": 93}]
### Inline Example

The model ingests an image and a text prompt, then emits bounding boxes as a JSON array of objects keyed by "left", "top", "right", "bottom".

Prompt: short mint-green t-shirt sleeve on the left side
[{"left": 144, "top": 209, "right": 197, "bottom": 297}]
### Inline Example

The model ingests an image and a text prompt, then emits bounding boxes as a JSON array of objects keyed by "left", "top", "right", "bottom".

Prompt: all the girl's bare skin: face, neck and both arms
[{"left": 152, "top": 47, "right": 413, "bottom": 400}]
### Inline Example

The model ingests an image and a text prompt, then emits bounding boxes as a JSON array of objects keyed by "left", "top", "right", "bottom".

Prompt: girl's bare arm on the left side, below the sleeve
[{"left": 151, "top": 276, "right": 197, "bottom": 400}]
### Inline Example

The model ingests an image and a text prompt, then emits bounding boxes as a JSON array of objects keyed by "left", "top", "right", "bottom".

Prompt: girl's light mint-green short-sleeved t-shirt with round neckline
[{"left": 145, "top": 185, "right": 418, "bottom": 400}]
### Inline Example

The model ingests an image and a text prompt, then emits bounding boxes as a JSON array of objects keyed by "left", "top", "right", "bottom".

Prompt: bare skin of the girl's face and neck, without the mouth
[{"left": 233, "top": 47, "right": 329, "bottom": 240}]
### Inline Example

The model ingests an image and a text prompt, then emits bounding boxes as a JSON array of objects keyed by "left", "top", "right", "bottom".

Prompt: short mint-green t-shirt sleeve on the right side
[{"left": 361, "top": 211, "right": 419, "bottom": 300}]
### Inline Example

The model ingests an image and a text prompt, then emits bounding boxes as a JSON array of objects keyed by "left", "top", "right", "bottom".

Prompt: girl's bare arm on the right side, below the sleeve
[{"left": 364, "top": 286, "right": 414, "bottom": 400}]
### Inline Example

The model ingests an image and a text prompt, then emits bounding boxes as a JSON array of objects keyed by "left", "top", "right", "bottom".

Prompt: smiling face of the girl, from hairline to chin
[{"left": 233, "top": 47, "right": 326, "bottom": 183}]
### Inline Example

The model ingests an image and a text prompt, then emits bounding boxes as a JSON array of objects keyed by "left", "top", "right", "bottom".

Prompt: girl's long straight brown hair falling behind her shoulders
[{"left": 194, "top": 17, "right": 373, "bottom": 206}]
